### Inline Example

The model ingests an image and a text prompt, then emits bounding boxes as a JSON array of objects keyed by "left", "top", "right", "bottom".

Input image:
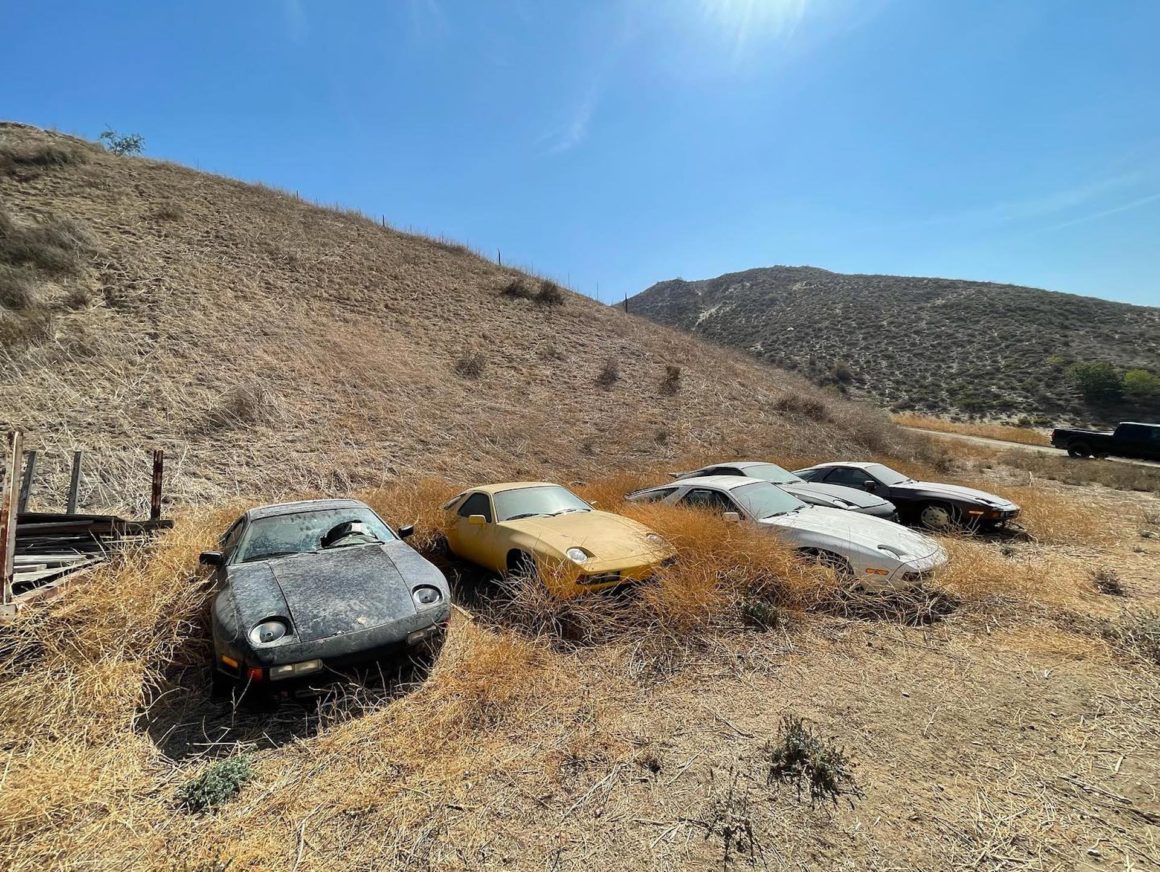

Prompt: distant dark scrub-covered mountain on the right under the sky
[{"left": 629, "top": 267, "right": 1160, "bottom": 417}]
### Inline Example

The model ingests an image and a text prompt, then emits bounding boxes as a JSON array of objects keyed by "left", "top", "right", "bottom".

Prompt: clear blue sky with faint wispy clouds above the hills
[{"left": 0, "top": 0, "right": 1160, "bottom": 305}]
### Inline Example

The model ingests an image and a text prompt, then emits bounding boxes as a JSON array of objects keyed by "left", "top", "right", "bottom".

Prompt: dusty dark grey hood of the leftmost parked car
[{"left": 230, "top": 542, "right": 449, "bottom": 641}]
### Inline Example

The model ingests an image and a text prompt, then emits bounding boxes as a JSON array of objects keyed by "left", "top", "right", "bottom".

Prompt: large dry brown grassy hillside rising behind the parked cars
[{"left": 0, "top": 125, "right": 892, "bottom": 514}]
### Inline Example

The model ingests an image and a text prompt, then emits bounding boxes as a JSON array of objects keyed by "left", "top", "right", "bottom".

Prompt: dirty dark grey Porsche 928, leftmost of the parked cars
[{"left": 201, "top": 500, "right": 451, "bottom": 695}]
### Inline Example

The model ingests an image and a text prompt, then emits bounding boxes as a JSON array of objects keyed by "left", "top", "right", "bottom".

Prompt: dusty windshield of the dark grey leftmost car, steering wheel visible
[{"left": 237, "top": 508, "right": 396, "bottom": 564}]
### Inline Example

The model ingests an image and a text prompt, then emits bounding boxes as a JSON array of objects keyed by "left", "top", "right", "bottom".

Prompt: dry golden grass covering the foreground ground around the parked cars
[{"left": 0, "top": 477, "right": 1157, "bottom": 870}]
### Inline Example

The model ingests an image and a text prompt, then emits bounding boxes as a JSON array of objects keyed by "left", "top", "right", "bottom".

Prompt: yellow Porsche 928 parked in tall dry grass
[{"left": 443, "top": 481, "right": 676, "bottom": 595}]
